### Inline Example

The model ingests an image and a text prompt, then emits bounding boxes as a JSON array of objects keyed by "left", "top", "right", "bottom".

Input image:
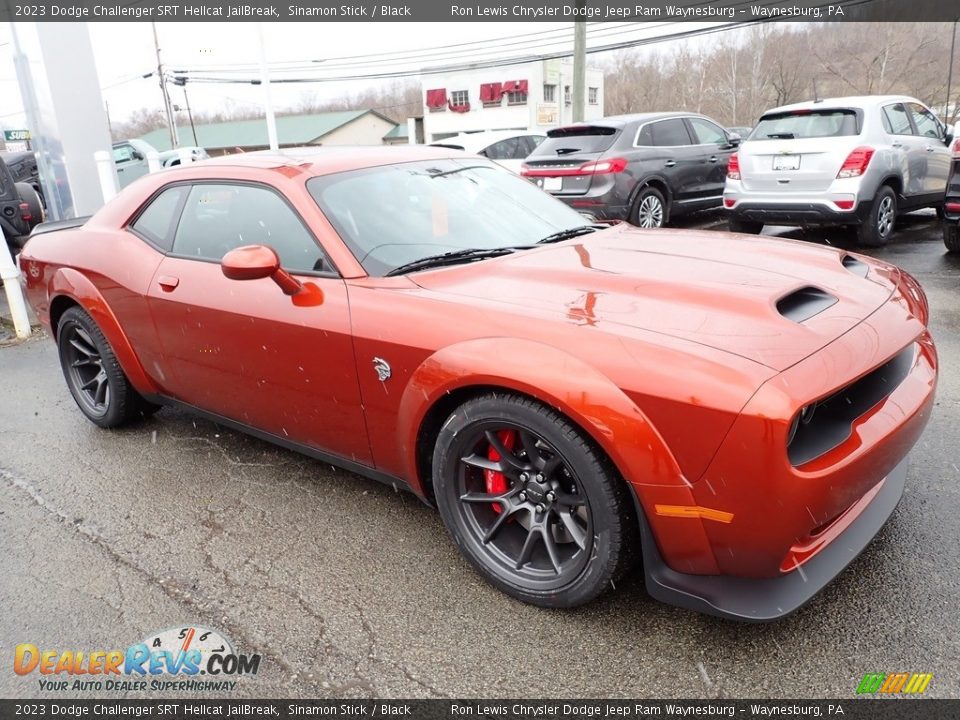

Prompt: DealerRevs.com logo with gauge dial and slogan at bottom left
[{"left": 13, "top": 626, "right": 260, "bottom": 692}]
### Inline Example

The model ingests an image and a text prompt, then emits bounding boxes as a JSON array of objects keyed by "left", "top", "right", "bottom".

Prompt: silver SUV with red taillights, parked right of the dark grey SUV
[{"left": 723, "top": 95, "right": 953, "bottom": 247}]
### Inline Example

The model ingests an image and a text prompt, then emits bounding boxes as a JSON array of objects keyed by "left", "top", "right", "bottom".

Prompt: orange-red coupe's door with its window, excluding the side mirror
[{"left": 148, "top": 181, "right": 370, "bottom": 463}]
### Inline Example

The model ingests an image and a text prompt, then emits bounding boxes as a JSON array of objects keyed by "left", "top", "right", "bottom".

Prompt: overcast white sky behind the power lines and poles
[{"left": 0, "top": 21, "right": 724, "bottom": 128}]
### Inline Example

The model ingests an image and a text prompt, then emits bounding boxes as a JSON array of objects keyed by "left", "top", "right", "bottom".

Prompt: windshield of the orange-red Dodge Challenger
[{"left": 307, "top": 158, "right": 586, "bottom": 276}]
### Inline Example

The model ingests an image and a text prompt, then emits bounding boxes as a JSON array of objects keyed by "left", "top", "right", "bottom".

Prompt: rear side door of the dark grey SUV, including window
[{"left": 637, "top": 118, "right": 705, "bottom": 205}]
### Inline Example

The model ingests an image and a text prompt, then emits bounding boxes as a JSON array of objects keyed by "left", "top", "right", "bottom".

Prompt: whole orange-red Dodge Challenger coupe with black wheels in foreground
[{"left": 21, "top": 148, "right": 937, "bottom": 620}]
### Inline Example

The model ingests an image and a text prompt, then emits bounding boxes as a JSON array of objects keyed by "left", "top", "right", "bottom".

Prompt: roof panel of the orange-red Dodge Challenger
[{"left": 199, "top": 145, "right": 476, "bottom": 175}]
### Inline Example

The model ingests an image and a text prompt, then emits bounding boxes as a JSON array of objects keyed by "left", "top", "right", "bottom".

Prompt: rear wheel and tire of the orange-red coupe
[{"left": 57, "top": 307, "right": 159, "bottom": 428}]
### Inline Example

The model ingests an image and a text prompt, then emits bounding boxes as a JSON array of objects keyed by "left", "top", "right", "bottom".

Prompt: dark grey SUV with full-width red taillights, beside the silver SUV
[{"left": 521, "top": 113, "right": 739, "bottom": 228}]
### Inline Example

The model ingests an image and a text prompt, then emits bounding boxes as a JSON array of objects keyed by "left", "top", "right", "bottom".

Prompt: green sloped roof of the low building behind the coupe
[{"left": 140, "top": 110, "right": 393, "bottom": 152}]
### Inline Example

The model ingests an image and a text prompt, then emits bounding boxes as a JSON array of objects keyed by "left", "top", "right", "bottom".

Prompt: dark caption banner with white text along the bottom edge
[{"left": 0, "top": 698, "right": 960, "bottom": 720}]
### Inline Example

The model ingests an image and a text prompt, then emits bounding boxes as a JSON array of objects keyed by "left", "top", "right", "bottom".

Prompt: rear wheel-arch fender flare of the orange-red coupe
[{"left": 47, "top": 267, "right": 160, "bottom": 395}]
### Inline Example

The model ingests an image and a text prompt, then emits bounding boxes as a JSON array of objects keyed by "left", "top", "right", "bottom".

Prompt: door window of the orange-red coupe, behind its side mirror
[{"left": 173, "top": 184, "right": 329, "bottom": 272}]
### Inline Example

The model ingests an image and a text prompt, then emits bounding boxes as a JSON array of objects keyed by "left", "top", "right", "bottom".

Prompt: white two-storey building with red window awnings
[{"left": 423, "top": 58, "right": 603, "bottom": 142}]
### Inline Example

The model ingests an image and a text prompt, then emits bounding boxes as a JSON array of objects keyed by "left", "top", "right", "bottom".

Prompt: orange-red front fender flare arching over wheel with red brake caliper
[{"left": 397, "top": 337, "right": 718, "bottom": 574}]
